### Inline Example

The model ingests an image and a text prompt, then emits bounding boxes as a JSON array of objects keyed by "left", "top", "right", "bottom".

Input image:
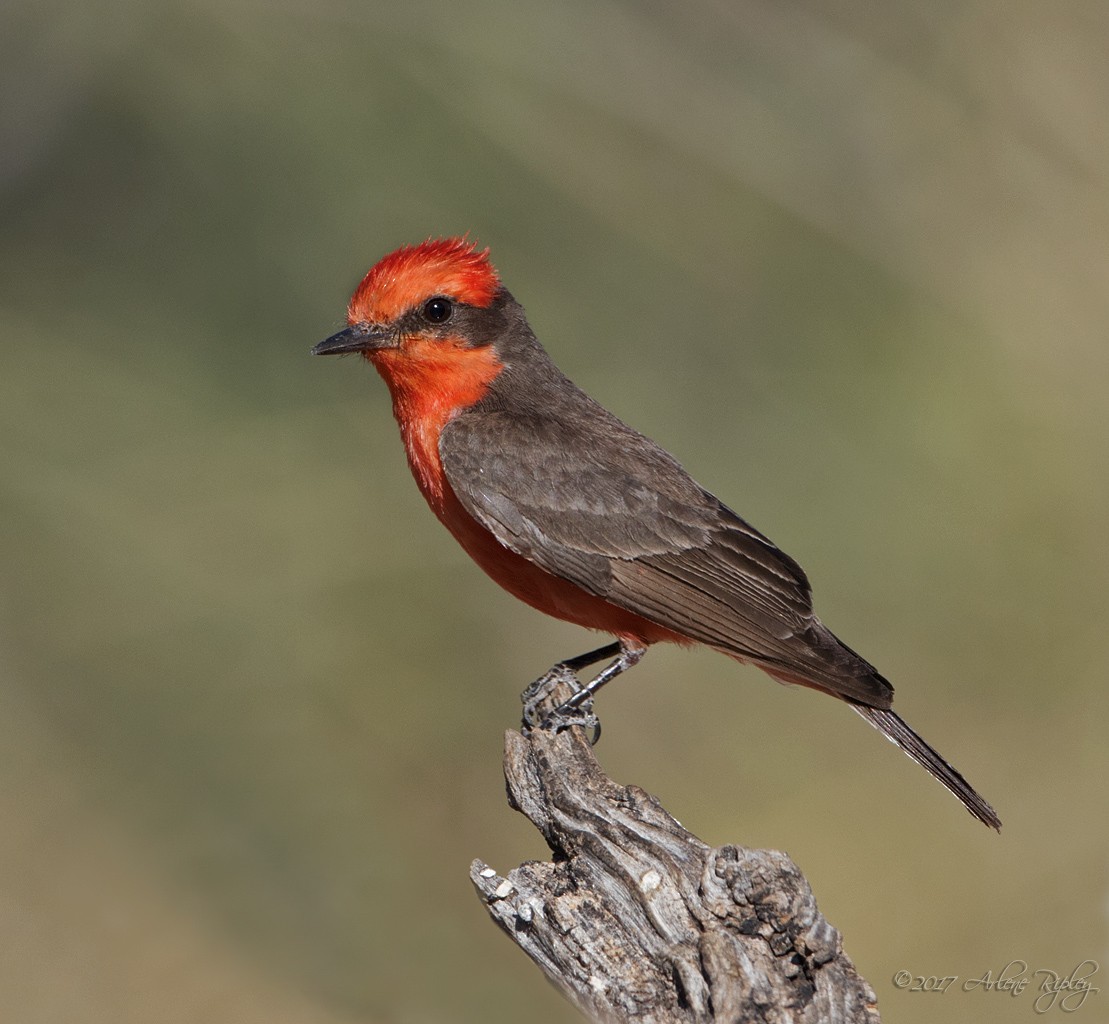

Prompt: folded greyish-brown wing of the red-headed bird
[{"left": 439, "top": 403, "right": 893, "bottom": 708}]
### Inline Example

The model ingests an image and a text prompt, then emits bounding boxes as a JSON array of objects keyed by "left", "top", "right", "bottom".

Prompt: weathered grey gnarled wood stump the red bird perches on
[{"left": 470, "top": 685, "right": 878, "bottom": 1024}]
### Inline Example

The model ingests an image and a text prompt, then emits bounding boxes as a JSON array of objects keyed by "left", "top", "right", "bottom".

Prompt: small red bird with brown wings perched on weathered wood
[{"left": 312, "top": 236, "right": 1001, "bottom": 830}]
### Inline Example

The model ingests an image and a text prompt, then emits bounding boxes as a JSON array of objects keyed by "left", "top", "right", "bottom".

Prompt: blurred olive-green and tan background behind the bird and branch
[{"left": 0, "top": 0, "right": 1109, "bottom": 1024}]
